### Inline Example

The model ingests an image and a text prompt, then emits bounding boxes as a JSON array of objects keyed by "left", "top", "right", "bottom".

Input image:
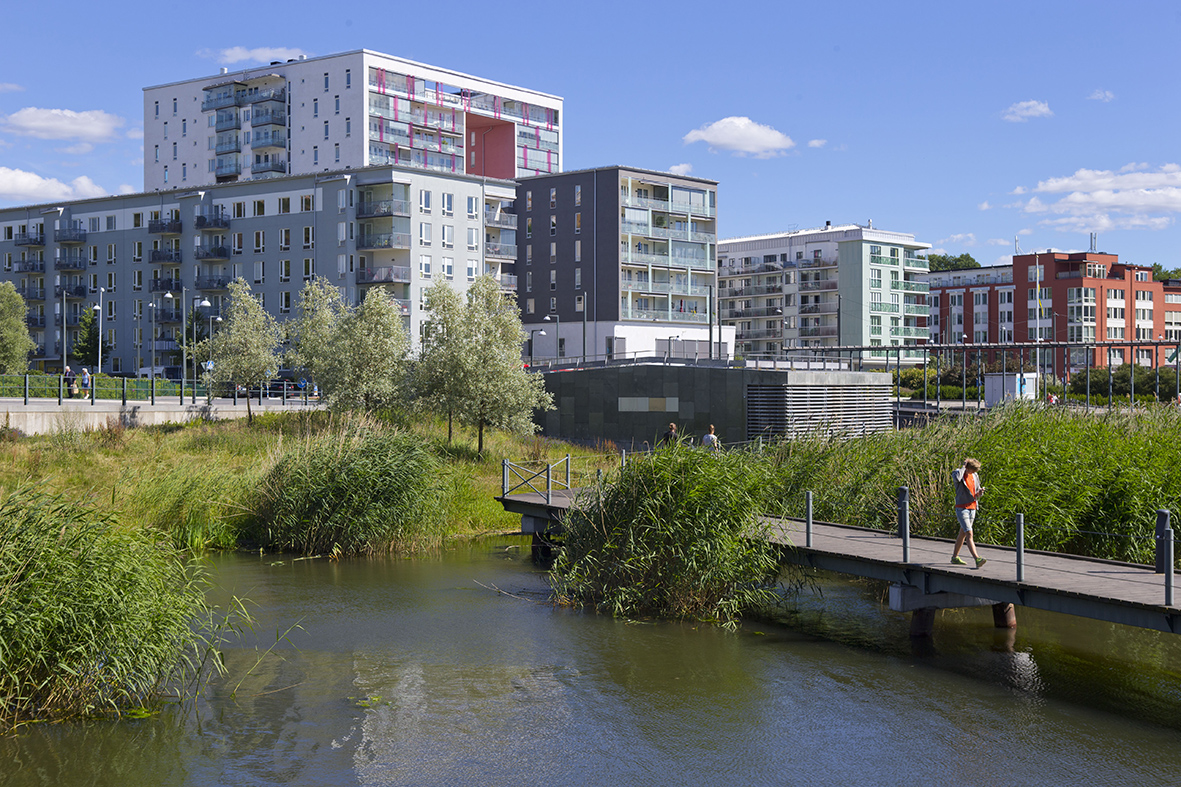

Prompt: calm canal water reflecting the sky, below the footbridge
[{"left": 0, "top": 538, "right": 1181, "bottom": 787}]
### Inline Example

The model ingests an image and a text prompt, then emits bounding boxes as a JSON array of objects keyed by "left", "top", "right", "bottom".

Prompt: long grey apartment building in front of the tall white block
[{"left": 0, "top": 165, "right": 516, "bottom": 373}]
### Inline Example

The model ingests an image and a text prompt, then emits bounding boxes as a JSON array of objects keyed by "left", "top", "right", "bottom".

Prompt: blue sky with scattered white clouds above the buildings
[{"left": 0, "top": 0, "right": 1181, "bottom": 268}]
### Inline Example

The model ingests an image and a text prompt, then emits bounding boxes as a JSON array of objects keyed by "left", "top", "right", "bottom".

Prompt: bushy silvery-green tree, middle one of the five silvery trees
[{"left": 312, "top": 287, "right": 410, "bottom": 411}]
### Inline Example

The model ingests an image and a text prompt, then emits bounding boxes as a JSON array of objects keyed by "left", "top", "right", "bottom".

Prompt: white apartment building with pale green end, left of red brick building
[{"left": 718, "top": 222, "right": 931, "bottom": 360}]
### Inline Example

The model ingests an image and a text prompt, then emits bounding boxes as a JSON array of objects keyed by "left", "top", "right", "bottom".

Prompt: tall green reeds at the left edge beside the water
[{"left": 0, "top": 487, "right": 205, "bottom": 730}]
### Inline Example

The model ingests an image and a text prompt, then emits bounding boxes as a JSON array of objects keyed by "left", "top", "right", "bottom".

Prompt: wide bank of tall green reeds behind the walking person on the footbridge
[{"left": 775, "top": 403, "right": 1181, "bottom": 562}]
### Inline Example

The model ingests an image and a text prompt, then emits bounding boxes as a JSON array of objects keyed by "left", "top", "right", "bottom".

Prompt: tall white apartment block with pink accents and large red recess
[{"left": 143, "top": 50, "right": 562, "bottom": 191}]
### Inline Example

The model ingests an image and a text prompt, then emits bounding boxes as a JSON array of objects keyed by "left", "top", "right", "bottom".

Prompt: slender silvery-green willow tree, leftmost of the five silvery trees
[{"left": 207, "top": 278, "right": 279, "bottom": 421}]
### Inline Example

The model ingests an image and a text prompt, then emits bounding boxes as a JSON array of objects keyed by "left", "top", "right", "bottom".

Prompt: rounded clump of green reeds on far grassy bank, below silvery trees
[{"left": 246, "top": 419, "right": 443, "bottom": 554}]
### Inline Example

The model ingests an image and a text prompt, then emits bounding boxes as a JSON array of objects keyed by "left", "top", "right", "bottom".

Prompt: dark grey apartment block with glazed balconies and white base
[{"left": 515, "top": 167, "right": 733, "bottom": 359}]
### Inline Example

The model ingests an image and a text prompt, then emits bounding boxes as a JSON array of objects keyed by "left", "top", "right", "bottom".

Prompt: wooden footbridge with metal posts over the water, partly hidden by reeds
[{"left": 497, "top": 457, "right": 1181, "bottom": 636}]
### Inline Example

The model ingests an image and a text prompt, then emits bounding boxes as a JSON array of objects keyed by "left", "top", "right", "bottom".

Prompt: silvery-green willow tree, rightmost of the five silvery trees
[{"left": 449, "top": 277, "right": 554, "bottom": 454}]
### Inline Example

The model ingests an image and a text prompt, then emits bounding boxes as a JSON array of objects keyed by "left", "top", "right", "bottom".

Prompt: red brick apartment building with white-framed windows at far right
[{"left": 927, "top": 252, "right": 1181, "bottom": 377}]
